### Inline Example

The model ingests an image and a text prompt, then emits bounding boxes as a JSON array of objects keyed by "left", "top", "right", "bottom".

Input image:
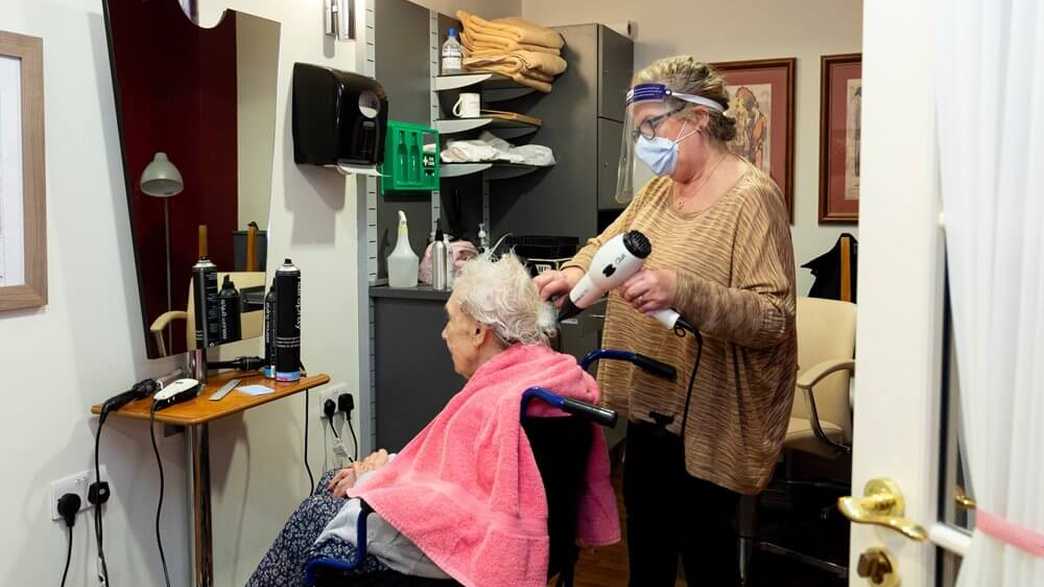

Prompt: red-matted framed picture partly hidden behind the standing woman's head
[{"left": 713, "top": 57, "right": 798, "bottom": 221}]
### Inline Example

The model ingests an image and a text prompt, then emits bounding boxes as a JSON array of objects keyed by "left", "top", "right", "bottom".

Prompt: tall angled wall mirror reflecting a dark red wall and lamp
[{"left": 104, "top": 0, "right": 280, "bottom": 358}]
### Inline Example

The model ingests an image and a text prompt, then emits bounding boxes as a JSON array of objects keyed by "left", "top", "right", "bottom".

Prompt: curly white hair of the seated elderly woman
[{"left": 453, "top": 253, "right": 555, "bottom": 345}]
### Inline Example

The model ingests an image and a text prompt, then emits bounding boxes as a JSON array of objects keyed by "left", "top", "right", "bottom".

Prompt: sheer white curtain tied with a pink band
[{"left": 935, "top": 0, "right": 1044, "bottom": 587}]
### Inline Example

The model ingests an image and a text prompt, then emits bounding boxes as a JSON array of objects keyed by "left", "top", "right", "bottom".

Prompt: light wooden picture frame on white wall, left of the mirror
[{"left": 0, "top": 31, "right": 47, "bottom": 310}]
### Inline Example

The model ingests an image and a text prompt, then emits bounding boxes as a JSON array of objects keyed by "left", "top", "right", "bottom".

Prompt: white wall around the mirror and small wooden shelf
[{"left": 0, "top": 0, "right": 358, "bottom": 586}]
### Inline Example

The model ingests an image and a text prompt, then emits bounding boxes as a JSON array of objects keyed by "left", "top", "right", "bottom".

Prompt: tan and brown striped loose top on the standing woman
[{"left": 569, "top": 165, "right": 798, "bottom": 493}]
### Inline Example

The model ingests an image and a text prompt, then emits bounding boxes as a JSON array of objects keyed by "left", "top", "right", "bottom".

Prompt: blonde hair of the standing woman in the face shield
[{"left": 633, "top": 55, "right": 736, "bottom": 143}]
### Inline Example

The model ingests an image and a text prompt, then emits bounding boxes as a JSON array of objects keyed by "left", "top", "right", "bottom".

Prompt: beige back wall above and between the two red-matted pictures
[{"left": 522, "top": 0, "right": 862, "bottom": 295}]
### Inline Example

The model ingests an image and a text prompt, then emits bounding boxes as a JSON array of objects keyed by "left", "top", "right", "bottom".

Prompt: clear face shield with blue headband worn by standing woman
[{"left": 616, "top": 84, "right": 725, "bottom": 204}]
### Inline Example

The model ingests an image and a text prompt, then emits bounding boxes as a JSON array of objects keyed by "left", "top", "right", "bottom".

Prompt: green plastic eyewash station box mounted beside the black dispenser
[{"left": 381, "top": 120, "right": 438, "bottom": 194}]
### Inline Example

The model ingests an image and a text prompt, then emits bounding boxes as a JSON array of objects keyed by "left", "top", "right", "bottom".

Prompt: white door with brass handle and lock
[{"left": 849, "top": 0, "right": 969, "bottom": 587}]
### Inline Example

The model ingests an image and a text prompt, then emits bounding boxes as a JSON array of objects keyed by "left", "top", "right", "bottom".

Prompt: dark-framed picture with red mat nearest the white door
[{"left": 820, "top": 53, "right": 862, "bottom": 224}]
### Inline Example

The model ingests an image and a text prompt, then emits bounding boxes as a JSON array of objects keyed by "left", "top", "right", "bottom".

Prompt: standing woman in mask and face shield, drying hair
[{"left": 536, "top": 56, "right": 797, "bottom": 587}]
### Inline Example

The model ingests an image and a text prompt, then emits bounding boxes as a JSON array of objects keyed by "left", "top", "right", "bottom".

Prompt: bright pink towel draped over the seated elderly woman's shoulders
[{"left": 350, "top": 345, "right": 620, "bottom": 587}]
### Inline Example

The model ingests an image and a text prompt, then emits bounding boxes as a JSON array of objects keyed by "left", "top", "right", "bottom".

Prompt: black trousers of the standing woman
[{"left": 623, "top": 422, "right": 739, "bottom": 587}]
